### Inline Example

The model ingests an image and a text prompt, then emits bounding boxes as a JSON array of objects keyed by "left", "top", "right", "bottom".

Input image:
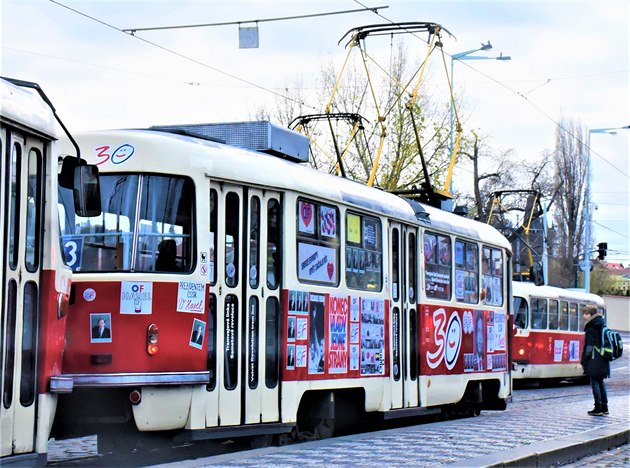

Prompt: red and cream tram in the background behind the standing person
[{"left": 512, "top": 281, "right": 605, "bottom": 380}]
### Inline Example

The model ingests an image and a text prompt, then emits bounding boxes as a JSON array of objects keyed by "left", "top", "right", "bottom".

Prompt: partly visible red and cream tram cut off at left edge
[{"left": 0, "top": 79, "right": 98, "bottom": 465}]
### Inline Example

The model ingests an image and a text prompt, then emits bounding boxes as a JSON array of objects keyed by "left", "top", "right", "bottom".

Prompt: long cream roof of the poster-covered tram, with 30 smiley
[{"left": 62, "top": 129, "right": 511, "bottom": 250}]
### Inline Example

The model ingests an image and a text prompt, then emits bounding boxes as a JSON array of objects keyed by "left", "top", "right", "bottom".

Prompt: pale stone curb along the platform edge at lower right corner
[{"left": 442, "top": 423, "right": 630, "bottom": 467}]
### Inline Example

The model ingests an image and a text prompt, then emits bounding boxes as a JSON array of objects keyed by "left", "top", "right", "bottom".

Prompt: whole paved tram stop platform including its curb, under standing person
[{"left": 161, "top": 384, "right": 630, "bottom": 468}]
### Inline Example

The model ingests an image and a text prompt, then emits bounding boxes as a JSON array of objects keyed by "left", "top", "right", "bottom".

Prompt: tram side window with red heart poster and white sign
[{"left": 297, "top": 199, "right": 339, "bottom": 286}]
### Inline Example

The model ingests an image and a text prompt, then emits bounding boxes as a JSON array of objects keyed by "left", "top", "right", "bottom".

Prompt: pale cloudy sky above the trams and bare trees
[{"left": 0, "top": 0, "right": 630, "bottom": 265}]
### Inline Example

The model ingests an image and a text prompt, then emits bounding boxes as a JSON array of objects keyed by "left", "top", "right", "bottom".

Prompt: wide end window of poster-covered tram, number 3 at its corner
[{"left": 59, "top": 174, "right": 194, "bottom": 272}]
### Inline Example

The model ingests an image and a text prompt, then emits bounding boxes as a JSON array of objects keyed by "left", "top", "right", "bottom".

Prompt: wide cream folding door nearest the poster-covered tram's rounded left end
[{"left": 207, "top": 184, "right": 281, "bottom": 426}]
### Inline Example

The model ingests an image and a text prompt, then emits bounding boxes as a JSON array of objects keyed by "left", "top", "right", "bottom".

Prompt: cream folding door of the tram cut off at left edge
[{"left": 0, "top": 127, "right": 47, "bottom": 456}]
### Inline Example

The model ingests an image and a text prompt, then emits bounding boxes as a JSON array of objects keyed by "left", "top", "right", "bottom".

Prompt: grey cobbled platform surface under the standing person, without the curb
[{"left": 189, "top": 387, "right": 630, "bottom": 467}]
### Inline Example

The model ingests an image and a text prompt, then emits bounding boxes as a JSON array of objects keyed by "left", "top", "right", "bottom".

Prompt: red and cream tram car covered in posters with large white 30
[{"left": 55, "top": 122, "right": 511, "bottom": 444}]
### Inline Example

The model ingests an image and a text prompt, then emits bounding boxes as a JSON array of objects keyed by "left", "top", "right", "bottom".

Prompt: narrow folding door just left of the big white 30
[{"left": 389, "top": 222, "right": 418, "bottom": 408}]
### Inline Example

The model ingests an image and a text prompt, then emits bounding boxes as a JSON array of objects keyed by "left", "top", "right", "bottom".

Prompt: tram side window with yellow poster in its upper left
[{"left": 346, "top": 212, "right": 383, "bottom": 291}]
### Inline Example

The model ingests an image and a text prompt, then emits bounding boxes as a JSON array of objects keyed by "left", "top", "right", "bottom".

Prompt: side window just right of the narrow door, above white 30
[{"left": 424, "top": 232, "right": 452, "bottom": 300}]
